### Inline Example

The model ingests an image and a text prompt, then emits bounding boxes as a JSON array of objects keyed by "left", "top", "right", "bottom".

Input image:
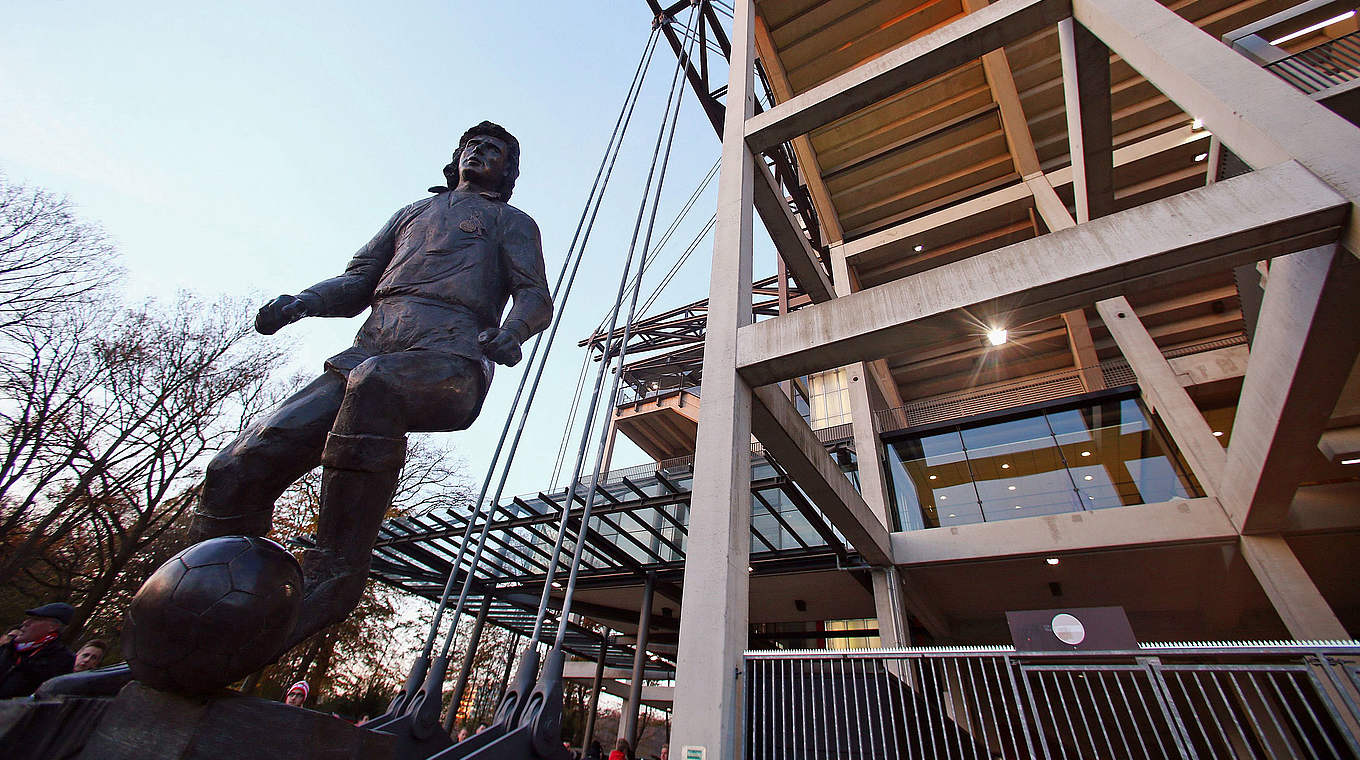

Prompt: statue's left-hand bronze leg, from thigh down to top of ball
[{"left": 189, "top": 373, "right": 345, "bottom": 542}]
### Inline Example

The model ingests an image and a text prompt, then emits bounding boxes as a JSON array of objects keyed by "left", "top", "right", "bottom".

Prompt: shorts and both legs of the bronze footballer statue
[{"left": 190, "top": 299, "right": 491, "bottom": 646}]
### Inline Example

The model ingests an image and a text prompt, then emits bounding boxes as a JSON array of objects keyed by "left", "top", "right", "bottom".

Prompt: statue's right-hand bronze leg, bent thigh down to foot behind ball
[{"left": 288, "top": 351, "right": 486, "bottom": 646}]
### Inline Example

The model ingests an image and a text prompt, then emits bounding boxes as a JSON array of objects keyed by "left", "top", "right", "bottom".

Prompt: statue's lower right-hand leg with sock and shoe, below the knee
[{"left": 284, "top": 432, "right": 407, "bottom": 651}]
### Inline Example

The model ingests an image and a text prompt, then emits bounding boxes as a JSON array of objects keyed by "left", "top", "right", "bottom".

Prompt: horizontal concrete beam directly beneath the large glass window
[{"left": 892, "top": 498, "right": 1238, "bottom": 567}]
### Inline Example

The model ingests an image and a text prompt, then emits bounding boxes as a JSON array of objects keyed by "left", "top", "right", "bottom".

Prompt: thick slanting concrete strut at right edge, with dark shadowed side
[{"left": 1219, "top": 245, "right": 1360, "bottom": 533}]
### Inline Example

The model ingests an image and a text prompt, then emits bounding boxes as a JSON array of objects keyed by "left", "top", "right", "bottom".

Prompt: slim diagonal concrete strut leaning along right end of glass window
[{"left": 1096, "top": 296, "right": 1227, "bottom": 496}]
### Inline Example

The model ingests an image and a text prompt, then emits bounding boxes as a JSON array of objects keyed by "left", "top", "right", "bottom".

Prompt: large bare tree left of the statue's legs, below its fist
[{"left": 0, "top": 290, "right": 282, "bottom": 629}]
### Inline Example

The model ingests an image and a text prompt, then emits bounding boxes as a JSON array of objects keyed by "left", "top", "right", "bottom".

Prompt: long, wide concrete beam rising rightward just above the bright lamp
[{"left": 739, "top": 162, "right": 1349, "bottom": 386}]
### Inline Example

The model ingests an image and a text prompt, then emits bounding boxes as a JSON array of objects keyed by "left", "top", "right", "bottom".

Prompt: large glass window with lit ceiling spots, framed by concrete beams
[{"left": 885, "top": 397, "right": 1193, "bottom": 530}]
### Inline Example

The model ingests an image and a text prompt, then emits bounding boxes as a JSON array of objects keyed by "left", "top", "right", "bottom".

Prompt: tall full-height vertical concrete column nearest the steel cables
[{"left": 670, "top": 0, "right": 761, "bottom": 760}]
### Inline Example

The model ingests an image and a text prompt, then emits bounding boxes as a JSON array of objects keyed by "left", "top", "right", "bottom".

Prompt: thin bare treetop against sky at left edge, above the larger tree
[{"left": 0, "top": 174, "right": 121, "bottom": 330}]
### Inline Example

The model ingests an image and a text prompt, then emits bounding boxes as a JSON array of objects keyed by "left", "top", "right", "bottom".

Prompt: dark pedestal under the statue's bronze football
[{"left": 79, "top": 681, "right": 394, "bottom": 760}]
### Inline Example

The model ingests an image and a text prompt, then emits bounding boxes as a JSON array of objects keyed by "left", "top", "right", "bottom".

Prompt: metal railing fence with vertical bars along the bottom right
[{"left": 745, "top": 642, "right": 1360, "bottom": 760}]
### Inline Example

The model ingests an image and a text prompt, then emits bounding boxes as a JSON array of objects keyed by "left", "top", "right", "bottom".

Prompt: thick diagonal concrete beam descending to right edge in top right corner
[{"left": 1072, "top": 0, "right": 1360, "bottom": 254}]
